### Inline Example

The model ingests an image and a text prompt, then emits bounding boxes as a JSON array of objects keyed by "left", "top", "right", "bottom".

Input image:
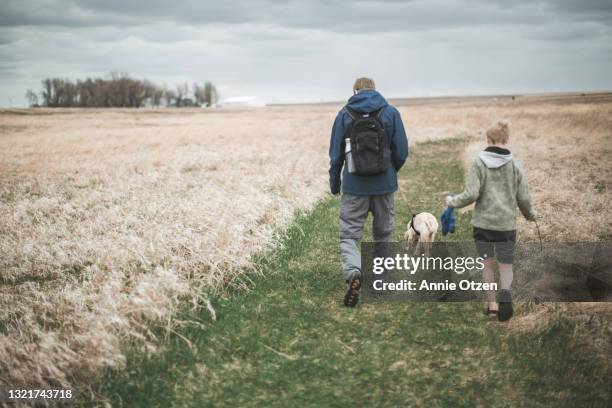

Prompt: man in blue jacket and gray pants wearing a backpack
[{"left": 329, "top": 78, "right": 408, "bottom": 307}]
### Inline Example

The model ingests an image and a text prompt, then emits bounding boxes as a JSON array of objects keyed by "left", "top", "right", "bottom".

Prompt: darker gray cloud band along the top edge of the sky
[{"left": 0, "top": 0, "right": 612, "bottom": 32}]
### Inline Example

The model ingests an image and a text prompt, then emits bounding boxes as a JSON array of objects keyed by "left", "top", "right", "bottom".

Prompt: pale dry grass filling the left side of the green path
[{"left": 0, "top": 109, "right": 333, "bottom": 385}]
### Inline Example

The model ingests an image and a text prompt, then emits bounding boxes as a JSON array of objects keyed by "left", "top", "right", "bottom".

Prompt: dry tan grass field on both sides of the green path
[{"left": 0, "top": 93, "right": 612, "bottom": 385}]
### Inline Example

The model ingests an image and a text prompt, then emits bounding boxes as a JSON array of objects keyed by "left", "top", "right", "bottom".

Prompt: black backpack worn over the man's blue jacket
[{"left": 345, "top": 106, "right": 391, "bottom": 176}]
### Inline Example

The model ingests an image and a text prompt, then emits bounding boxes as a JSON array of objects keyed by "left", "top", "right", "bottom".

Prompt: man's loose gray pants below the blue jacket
[{"left": 340, "top": 193, "right": 395, "bottom": 280}]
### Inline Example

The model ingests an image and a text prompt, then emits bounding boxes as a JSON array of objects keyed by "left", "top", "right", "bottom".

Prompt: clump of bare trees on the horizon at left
[{"left": 26, "top": 73, "right": 218, "bottom": 108}]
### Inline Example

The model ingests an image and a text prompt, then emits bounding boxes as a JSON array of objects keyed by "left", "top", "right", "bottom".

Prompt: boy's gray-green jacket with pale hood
[{"left": 450, "top": 146, "right": 536, "bottom": 231}]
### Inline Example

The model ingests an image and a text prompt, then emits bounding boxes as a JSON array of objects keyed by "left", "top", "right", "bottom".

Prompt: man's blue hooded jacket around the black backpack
[{"left": 329, "top": 89, "right": 408, "bottom": 195}]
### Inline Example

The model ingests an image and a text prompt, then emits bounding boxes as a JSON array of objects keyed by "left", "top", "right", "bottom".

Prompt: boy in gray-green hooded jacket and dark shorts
[{"left": 446, "top": 122, "right": 536, "bottom": 321}]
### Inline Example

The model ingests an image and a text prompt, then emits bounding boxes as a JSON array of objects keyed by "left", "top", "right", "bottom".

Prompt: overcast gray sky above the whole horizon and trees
[{"left": 0, "top": 0, "right": 612, "bottom": 106}]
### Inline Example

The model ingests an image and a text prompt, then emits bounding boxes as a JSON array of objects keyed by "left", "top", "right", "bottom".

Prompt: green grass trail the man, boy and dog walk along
[{"left": 99, "top": 140, "right": 610, "bottom": 407}]
